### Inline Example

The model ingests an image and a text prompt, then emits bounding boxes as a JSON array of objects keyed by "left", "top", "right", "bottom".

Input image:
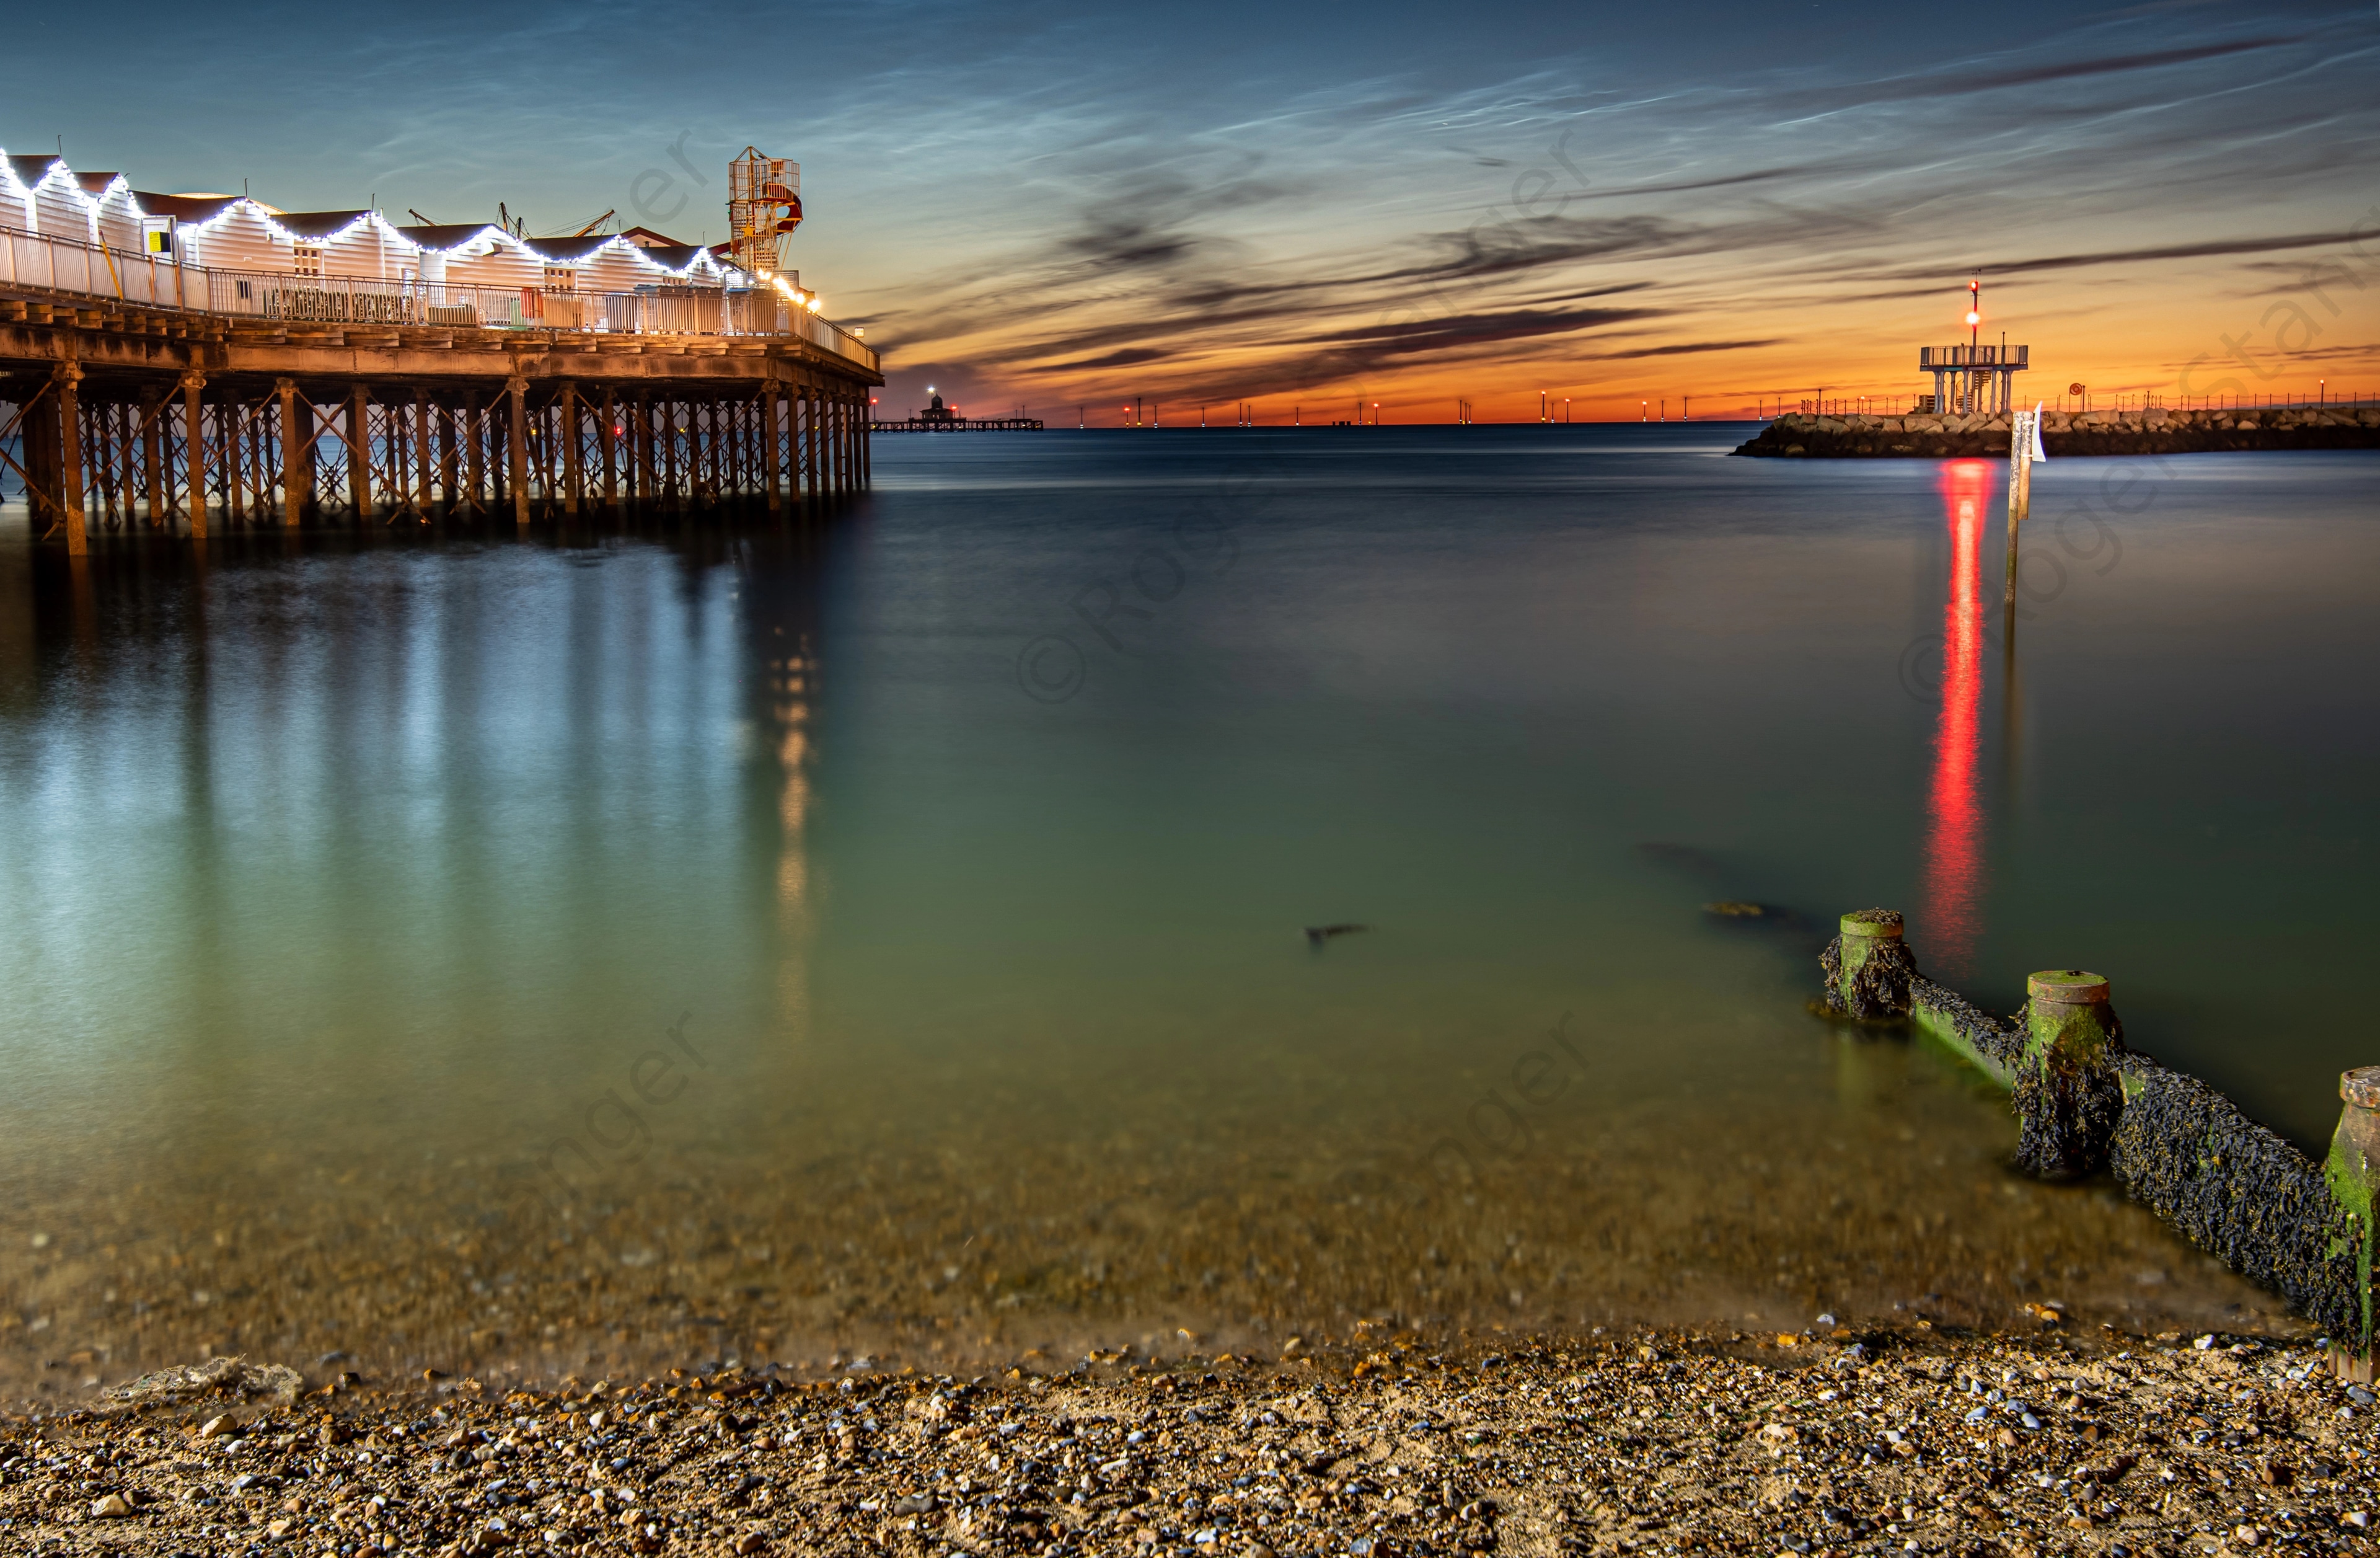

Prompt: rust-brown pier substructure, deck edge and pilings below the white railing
[{"left": 0, "top": 286, "right": 881, "bottom": 538}]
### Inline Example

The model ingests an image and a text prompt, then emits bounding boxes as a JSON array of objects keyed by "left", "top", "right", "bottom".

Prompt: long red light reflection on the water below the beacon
[{"left": 1923, "top": 460, "right": 1992, "bottom": 975}]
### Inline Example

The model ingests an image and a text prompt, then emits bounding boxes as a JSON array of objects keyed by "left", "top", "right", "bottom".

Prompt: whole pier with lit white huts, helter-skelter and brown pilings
[{"left": 0, "top": 148, "right": 883, "bottom": 552}]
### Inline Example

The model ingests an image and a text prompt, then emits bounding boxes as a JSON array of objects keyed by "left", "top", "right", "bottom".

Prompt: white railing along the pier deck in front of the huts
[{"left": 0, "top": 229, "right": 883, "bottom": 371}]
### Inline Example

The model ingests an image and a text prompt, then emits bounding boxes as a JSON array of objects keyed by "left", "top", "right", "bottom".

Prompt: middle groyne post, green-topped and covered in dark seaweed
[{"left": 2016, "top": 967, "right": 2123, "bottom": 1179}]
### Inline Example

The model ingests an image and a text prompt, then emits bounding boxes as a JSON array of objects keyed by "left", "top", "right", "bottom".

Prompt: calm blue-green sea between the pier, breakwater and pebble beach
[{"left": 0, "top": 429, "right": 2380, "bottom": 1379}]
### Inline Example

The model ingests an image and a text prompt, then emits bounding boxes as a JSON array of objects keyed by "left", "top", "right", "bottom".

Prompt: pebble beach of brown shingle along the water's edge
[{"left": 0, "top": 1315, "right": 2380, "bottom": 1558}]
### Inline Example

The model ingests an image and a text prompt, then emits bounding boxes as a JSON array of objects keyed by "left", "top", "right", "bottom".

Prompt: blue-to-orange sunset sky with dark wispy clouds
[{"left": 0, "top": 0, "right": 2380, "bottom": 427}]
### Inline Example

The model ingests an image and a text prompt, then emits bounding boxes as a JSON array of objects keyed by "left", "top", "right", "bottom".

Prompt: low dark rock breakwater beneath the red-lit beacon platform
[{"left": 1735, "top": 405, "right": 2380, "bottom": 460}]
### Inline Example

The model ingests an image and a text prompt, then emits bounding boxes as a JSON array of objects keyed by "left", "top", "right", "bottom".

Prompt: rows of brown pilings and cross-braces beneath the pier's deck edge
[{"left": 9, "top": 357, "right": 871, "bottom": 552}]
